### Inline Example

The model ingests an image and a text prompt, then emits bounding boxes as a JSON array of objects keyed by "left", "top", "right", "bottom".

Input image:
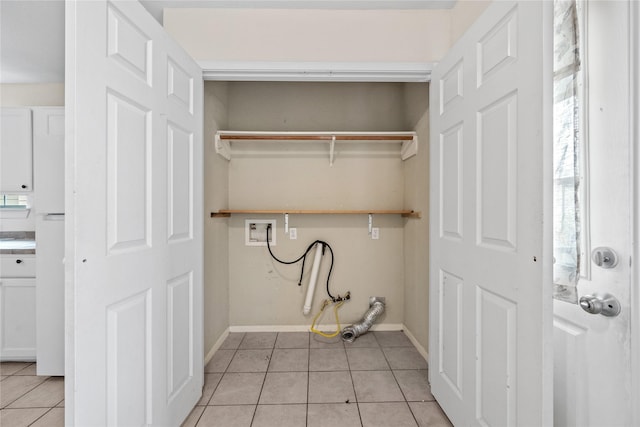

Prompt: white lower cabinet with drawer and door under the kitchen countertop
[{"left": 0, "top": 255, "right": 36, "bottom": 361}]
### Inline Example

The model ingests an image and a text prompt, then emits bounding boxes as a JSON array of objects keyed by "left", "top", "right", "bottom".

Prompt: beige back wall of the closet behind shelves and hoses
[{"left": 228, "top": 83, "right": 416, "bottom": 326}]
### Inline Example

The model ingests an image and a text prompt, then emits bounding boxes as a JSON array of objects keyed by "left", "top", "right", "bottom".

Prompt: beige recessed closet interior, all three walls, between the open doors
[{"left": 204, "top": 81, "right": 429, "bottom": 363}]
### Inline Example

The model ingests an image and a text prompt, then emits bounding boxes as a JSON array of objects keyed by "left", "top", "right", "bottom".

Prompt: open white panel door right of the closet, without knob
[{"left": 429, "top": 1, "right": 553, "bottom": 426}]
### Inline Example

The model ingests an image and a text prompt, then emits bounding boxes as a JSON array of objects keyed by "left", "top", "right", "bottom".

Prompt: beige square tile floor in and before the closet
[{"left": 183, "top": 332, "right": 451, "bottom": 427}]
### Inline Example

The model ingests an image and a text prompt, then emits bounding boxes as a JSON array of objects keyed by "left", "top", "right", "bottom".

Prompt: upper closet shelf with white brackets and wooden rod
[{"left": 215, "top": 131, "right": 418, "bottom": 165}]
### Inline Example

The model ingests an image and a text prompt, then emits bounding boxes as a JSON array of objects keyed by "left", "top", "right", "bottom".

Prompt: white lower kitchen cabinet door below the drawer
[{"left": 0, "top": 279, "right": 36, "bottom": 361}]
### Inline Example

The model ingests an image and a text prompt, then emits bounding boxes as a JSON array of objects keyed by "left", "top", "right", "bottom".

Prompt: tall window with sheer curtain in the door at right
[{"left": 553, "top": 0, "right": 585, "bottom": 304}]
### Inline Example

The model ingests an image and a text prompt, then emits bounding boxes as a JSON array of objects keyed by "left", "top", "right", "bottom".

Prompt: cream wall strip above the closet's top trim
[{"left": 164, "top": 9, "right": 450, "bottom": 62}]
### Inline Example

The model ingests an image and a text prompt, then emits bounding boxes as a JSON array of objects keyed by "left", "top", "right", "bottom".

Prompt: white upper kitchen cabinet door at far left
[{"left": 0, "top": 108, "right": 33, "bottom": 193}]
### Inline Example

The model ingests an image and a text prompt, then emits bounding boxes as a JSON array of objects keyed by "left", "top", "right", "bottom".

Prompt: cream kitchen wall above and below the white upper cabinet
[{"left": 0, "top": 83, "right": 64, "bottom": 231}]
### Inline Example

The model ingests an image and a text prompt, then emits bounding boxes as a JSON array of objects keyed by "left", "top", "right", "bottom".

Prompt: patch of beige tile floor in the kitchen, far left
[{"left": 0, "top": 362, "right": 64, "bottom": 427}]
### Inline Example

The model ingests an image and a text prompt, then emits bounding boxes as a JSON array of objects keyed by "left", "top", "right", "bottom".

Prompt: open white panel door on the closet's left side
[{"left": 65, "top": 0, "right": 203, "bottom": 426}]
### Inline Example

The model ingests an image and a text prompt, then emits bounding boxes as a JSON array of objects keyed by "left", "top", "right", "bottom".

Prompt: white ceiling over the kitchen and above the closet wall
[{"left": 0, "top": 0, "right": 456, "bottom": 83}]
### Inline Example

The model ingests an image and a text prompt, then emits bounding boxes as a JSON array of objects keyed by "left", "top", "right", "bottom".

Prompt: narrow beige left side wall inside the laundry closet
[{"left": 204, "top": 82, "right": 229, "bottom": 353}]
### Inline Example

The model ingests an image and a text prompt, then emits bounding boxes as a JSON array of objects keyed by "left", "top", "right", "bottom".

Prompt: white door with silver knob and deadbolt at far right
[{"left": 554, "top": 1, "right": 638, "bottom": 427}]
